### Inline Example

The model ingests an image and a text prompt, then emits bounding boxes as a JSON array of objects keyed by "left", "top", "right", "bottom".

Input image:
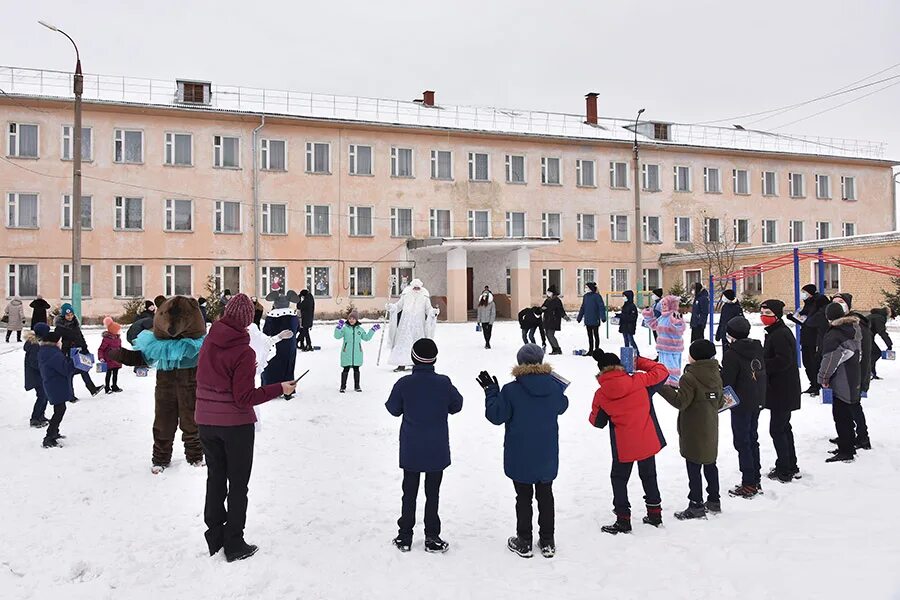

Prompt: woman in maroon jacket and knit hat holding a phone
[{"left": 195, "top": 294, "right": 296, "bottom": 562}]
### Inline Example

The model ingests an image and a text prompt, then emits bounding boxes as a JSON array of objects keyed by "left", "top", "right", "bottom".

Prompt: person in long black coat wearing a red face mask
[{"left": 760, "top": 299, "right": 800, "bottom": 483}]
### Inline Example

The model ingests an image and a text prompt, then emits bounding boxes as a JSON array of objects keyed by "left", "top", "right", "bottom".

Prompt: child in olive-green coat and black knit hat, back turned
[{"left": 659, "top": 339, "right": 725, "bottom": 520}]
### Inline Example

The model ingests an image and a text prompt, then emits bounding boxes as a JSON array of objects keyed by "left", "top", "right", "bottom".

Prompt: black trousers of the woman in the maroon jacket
[{"left": 199, "top": 423, "right": 255, "bottom": 554}]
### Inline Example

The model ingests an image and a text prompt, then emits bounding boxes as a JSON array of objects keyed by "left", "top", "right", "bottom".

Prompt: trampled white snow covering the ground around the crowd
[{"left": 0, "top": 320, "right": 900, "bottom": 600}]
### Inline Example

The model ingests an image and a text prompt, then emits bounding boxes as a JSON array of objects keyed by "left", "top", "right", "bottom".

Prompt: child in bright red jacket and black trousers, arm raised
[{"left": 590, "top": 351, "right": 669, "bottom": 535}]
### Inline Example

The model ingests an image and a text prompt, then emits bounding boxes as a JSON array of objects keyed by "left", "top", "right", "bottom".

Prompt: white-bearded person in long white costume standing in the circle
[{"left": 385, "top": 279, "right": 440, "bottom": 371}]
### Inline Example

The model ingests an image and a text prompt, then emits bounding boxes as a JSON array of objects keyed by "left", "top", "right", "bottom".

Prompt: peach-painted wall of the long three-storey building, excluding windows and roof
[{"left": 0, "top": 99, "right": 892, "bottom": 316}]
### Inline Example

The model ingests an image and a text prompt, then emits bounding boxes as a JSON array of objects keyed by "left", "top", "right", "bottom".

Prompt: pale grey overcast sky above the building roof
[{"left": 0, "top": 0, "right": 900, "bottom": 168}]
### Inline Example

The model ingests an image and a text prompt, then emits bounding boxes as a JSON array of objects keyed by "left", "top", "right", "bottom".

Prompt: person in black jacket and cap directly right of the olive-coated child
[{"left": 722, "top": 316, "right": 766, "bottom": 498}]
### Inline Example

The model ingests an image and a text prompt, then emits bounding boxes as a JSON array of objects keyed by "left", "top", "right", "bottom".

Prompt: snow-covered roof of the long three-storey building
[{"left": 0, "top": 66, "right": 887, "bottom": 162}]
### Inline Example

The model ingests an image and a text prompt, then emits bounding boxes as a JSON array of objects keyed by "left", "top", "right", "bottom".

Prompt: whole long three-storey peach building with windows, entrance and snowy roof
[{"left": 0, "top": 67, "right": 895, "bottom": 321}]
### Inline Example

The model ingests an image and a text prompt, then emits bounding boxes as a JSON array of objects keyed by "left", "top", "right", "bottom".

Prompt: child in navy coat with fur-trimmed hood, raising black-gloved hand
[{"left": 478, "top": 344, "right": 569, "bottom": 558}]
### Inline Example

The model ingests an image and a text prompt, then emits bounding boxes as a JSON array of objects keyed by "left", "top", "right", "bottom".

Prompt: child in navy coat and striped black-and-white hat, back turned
[{"left": 385, "top": 338, "right": 463, "bottom": 552}]
